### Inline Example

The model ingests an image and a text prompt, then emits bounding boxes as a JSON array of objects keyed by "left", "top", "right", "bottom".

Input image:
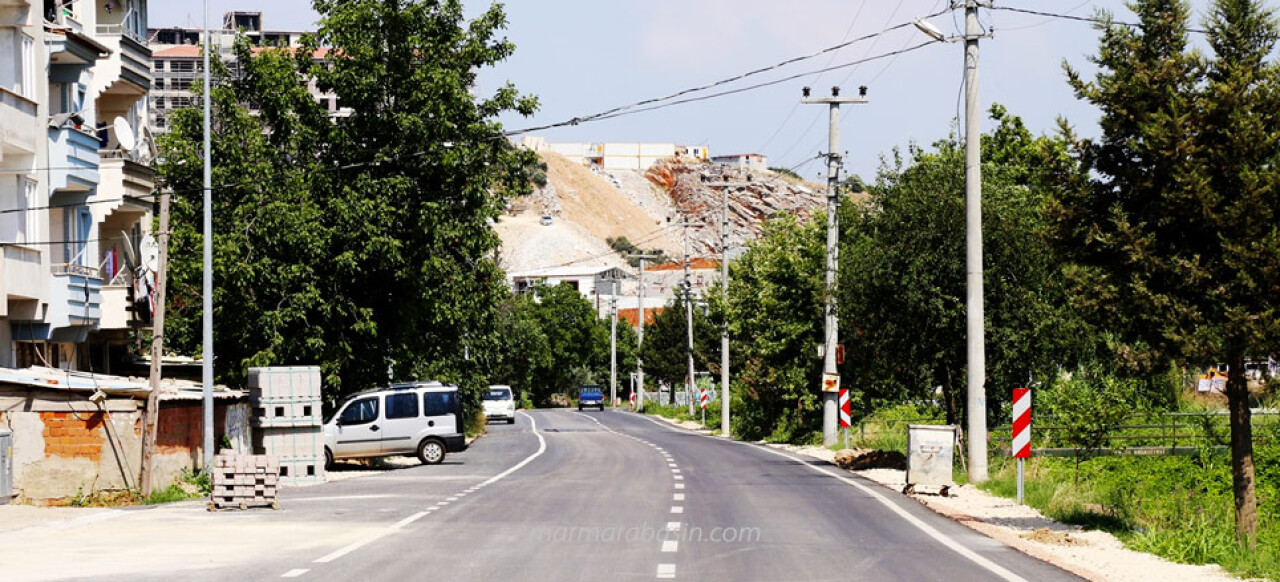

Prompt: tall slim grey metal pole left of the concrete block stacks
[{"left": 202, "top": 0, "right": 214, "bottom": 475}]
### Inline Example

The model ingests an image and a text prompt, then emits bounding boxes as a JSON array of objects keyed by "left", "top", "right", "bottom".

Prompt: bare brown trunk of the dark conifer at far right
[{"left": 1226, "top": 352, "right": 1258, "bottom": 547}]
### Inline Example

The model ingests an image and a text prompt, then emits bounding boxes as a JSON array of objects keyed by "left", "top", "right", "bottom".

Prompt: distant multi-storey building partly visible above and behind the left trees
[{"left": 147, "top": 12, "right": 351, "bottom": 133}]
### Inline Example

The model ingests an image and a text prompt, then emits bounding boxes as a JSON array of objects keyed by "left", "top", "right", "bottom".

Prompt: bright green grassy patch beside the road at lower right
[{"left": 979, "top": 437, "right": 1280, "bottom": 581}]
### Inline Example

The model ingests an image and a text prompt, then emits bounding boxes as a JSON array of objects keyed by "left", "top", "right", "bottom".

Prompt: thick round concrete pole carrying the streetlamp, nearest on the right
[{"left": 964, "top": 0, "right": 987, "bottom": 484}]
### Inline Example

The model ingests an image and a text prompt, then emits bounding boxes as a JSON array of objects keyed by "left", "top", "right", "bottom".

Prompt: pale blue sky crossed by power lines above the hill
[{"left": 148, "top": 0, "right": 1210, "bottom": 182}]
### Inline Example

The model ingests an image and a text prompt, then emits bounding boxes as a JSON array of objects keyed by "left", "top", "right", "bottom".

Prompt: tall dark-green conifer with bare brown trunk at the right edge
[{"left": 1059, "top": 0, "right": 1280, "bottom": 544}]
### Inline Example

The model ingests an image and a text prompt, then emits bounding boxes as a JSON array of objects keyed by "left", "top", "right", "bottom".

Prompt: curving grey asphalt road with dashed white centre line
[{"left": 12, "top": 411, "right": 1076, "bottom": 582}]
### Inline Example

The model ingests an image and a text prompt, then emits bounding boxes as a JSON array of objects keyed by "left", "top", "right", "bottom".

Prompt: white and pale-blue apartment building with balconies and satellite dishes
[{"left": 0, "top": 0, "right": 155, "bottom": 372}]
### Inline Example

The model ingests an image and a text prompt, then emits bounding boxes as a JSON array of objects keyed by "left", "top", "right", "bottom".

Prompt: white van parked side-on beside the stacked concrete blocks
[{"left": 324, "top": 381, "right": 467, "bottom": 466}]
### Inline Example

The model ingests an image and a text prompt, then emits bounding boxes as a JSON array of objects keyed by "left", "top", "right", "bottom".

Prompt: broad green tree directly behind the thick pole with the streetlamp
[{"left": 841, "top": 105, "right": 1092, "bottom": 423}]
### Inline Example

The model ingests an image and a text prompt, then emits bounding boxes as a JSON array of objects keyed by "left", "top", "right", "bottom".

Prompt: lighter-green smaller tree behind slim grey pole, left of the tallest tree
[{"left": 157, "top": 40, "right": 330, "bottom": 391}]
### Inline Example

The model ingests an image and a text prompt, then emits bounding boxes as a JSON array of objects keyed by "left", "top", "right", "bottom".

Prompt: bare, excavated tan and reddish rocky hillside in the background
[{"left": 494, "top": 152, "right": 823, "bottom": 271}]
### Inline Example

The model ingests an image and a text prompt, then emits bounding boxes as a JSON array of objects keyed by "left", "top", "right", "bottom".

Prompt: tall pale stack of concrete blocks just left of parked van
[{"left": 248, "top": 366, "right": 324, "bottom": 485}]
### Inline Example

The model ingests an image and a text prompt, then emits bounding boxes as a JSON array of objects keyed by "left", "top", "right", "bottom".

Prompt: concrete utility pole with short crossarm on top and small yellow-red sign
[{"left": 800, "top": 87, "right": 868, "bottom": 446}]
